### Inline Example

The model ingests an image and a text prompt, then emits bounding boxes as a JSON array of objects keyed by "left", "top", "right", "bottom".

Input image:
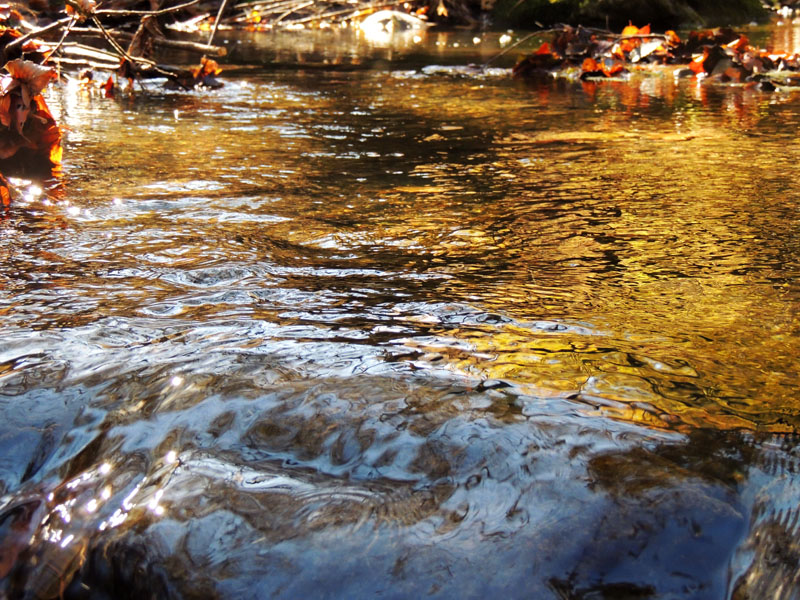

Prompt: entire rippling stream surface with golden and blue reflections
[{"left": 0, "top": 22, "right": 800, "bottom": 600}]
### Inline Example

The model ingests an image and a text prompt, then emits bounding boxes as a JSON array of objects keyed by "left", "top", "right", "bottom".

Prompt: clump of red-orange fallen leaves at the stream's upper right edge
[{"left": 513, "top": 24, "right": 800, "bottom": 91}]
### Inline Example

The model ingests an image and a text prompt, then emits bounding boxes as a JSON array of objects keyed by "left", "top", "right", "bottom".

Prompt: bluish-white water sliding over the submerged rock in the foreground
[{"left": 0, "top": 370, "right": 798, "bottom": 599}]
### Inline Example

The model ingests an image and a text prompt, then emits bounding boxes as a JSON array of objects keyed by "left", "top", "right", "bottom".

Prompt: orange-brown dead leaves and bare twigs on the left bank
[{"left": 0, "top": 0, "right": 234, "bottom": 205}]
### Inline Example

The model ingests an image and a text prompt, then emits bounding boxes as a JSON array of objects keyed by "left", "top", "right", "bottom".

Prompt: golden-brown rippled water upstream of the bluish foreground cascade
[{"left": 28, "top": 57, "right": 800, "bottom": 431}]
